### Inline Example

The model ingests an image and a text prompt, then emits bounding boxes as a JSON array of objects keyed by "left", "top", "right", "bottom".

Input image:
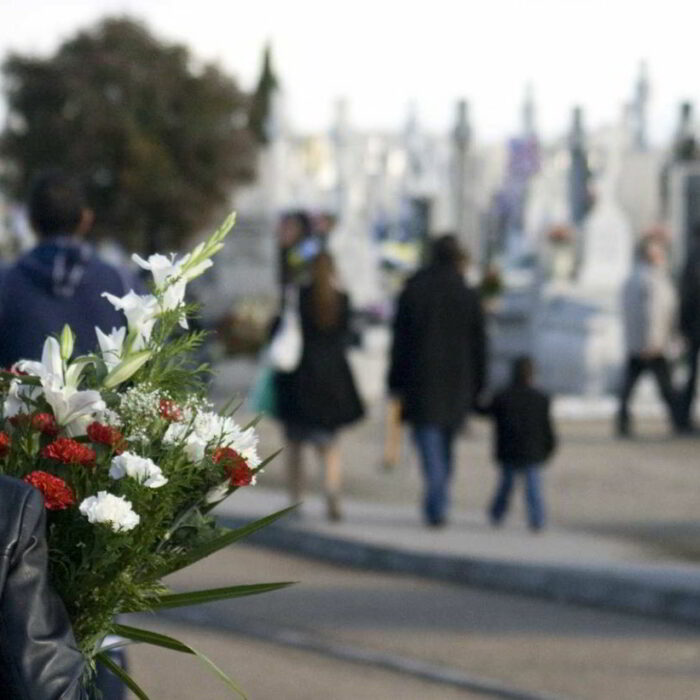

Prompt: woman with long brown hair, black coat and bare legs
[{"left": 276, "top": 252, "right": 364, "bottom": 521}]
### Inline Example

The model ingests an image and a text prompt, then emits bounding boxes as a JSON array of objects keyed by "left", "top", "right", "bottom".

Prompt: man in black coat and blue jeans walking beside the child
[{"left": 388, "top": 235, "right": 486, "bottom": 527}]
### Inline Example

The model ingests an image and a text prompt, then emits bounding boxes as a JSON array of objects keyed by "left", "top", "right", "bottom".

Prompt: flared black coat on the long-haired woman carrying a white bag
[{"left": 276, "top": 287, "right": 364, "bottom": 430}]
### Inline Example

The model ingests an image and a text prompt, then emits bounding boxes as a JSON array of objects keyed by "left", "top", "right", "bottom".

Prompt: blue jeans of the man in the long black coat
[{"left": 413, "top": 424, "right": 454, "bottom": 525}]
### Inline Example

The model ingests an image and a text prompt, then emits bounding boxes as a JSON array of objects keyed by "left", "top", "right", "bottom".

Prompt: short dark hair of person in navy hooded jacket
[{"left": 27, "top": 169, "right": 87, "bottom": 236}]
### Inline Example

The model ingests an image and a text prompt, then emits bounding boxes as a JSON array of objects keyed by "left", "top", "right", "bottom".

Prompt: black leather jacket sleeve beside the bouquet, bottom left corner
[{"left": 0, "top": 489, "right": 87, "bottom": 700}]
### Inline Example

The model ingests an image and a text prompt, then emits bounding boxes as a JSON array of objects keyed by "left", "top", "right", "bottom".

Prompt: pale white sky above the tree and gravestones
[{"left": 0, "top": 0, "right": 700, "bottom": 143}]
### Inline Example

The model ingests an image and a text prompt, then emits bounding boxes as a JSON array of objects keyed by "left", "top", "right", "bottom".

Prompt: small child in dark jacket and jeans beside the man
[{"left": 489, "top": 357, "right": 556, "bottom": 532}]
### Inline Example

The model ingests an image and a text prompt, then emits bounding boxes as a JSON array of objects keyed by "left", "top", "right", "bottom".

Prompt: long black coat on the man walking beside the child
[{"left": 388, "top": 265, "right": 486, "bottom": 428}]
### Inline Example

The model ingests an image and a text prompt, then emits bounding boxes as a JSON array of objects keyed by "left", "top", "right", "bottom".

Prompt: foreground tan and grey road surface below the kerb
[{"left": 124, "top": 545, "right": 700, "bottom": 700}]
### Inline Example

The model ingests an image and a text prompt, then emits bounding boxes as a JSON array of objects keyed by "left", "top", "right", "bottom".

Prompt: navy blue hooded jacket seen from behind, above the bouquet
[{"left": 0, "top": 237, "right": 132, "bottom": 367}]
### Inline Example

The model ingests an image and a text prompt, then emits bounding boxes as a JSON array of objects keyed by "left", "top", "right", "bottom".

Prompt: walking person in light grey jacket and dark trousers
[{"left": 617, "top": 236, "right": 682, "bottom": 437}]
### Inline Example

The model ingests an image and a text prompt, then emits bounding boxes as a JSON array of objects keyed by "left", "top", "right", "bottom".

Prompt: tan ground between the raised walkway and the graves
[{"left": 247, "top": 406, "right": 700, "bottom": 560}]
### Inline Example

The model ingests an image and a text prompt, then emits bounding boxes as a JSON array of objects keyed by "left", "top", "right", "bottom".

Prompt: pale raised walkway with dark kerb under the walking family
[{"left": 216, "top": 486, "right": 700, "bottom": 625}]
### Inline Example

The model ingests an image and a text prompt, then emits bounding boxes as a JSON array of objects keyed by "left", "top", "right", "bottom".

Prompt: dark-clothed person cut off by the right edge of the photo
[{"left": 679, "top": 224, "right": 700, "bottom": 432}]
